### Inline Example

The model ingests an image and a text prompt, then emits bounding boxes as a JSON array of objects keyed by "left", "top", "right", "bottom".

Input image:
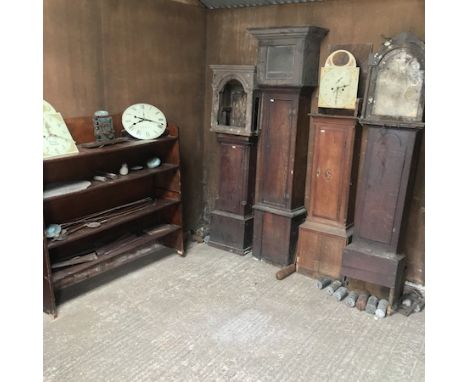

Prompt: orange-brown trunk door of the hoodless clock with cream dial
[{"left": 311, "top": 125, "right": 347, "bottom": 221}]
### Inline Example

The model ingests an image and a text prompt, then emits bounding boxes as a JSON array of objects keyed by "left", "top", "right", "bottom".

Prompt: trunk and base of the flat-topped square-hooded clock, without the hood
[{"left": 252, "top": 87, "right": 312, "bottom": 265}]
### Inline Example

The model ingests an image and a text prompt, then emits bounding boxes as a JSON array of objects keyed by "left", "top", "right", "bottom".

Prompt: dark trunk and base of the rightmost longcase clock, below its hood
[{"left": 342, "top": 121, "right": 421, "bottom": 305}]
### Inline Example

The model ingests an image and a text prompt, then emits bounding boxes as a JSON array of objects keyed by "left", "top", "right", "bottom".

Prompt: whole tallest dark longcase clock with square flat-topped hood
[{"left": 249, "top": 26, "right": 328, "bottom": 265}]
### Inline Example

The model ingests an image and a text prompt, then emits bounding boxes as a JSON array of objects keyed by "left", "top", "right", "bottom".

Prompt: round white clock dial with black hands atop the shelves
[{"left": 122, "top": 103, "right": 166, "bottom": 139}]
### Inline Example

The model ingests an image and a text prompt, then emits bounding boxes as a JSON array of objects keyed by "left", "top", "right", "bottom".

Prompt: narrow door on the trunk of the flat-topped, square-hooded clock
[{"left": 260, "top": 95, "right": 293, "bottom": 207}]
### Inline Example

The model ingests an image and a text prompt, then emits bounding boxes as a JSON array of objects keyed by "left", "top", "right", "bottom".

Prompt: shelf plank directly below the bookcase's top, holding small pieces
[{"left": 44, "top": 163, "right": 179, "bottom": 203}]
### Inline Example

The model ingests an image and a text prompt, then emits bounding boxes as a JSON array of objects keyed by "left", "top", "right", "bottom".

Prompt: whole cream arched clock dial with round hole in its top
[{"left": 318, "top": 50, "right": 359, "bottom": 110}]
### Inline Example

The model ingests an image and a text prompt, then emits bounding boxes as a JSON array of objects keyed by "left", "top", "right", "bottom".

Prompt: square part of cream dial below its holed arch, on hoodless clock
[{"left": 318, "top": 66, "right": 359, "bottom": 109}]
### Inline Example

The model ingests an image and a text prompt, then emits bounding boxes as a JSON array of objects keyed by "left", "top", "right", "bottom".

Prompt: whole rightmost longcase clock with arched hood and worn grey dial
[{"left": 342, "top": 33, "right": 424, "bottom": 311}]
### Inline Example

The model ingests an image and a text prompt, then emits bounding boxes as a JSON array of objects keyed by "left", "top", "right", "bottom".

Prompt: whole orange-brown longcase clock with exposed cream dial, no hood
[{"left": 296, "top": 50, "right": 360, "bottom": 278}]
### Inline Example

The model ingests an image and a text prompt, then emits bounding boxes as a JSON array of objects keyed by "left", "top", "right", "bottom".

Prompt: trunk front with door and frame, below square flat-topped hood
[{"left": 256, "top": 91, "right": 298, "bottom": 208}]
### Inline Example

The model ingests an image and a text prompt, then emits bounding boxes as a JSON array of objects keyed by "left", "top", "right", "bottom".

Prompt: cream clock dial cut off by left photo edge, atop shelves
[{"left": 42, "top": 112, "right": 78, "bottom": 158}]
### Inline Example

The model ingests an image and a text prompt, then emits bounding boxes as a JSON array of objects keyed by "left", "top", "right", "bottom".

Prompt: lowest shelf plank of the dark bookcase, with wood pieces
[{"left": 52, "top": 224, "right": 182, "bottom": 289}]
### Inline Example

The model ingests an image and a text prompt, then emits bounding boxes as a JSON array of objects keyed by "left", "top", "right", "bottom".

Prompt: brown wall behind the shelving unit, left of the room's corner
[{"left": 44, "top": 0, "right": 206, "bottom": 228}]
